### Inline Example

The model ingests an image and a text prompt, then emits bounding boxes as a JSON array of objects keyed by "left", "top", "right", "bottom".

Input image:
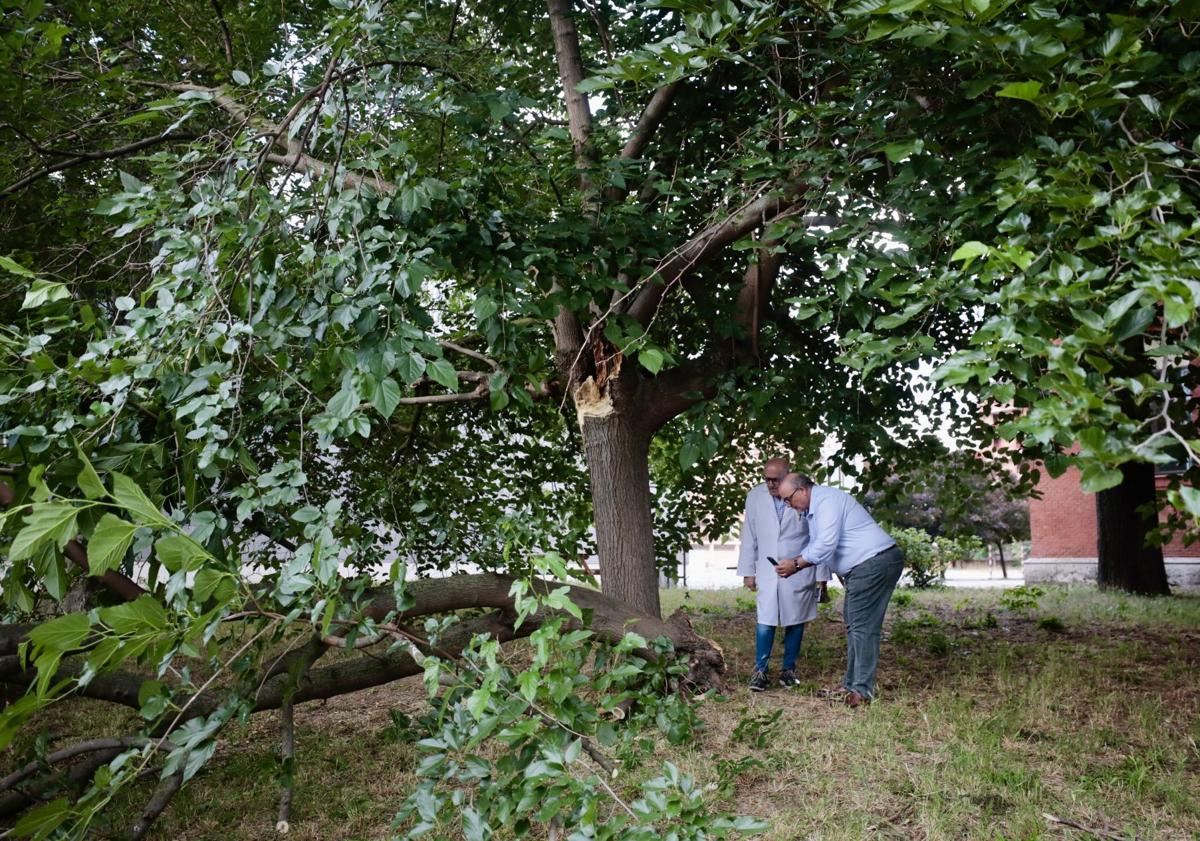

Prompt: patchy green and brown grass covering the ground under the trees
[{"left": 4, "top": 588, "right": 1200, "bottom": 841}]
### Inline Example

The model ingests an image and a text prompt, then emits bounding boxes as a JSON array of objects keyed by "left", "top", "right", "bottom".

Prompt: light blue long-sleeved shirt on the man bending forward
[{"left": 804, "top": 485, "right": 896, "bottom": 576}]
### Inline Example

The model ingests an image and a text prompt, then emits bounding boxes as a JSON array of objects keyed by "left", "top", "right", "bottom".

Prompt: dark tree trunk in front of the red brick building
[{"left": 1096, "top": 462, "right": 1171, "bottom": 595}]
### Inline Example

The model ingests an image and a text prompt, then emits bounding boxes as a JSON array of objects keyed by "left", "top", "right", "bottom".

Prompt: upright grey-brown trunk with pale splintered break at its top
[{"left": 576, "top": 380, "right": 661, "bottom": 617}]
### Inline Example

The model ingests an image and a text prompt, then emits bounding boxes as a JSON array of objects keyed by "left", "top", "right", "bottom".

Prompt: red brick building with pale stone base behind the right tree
[{"left": 1025, "top": 468, "right": 1200, "bottom": 589}]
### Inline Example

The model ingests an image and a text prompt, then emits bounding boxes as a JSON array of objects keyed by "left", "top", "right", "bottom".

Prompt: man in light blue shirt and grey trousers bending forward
[{"left": 775, "top": 473, "right": 904, "bottom": 707}]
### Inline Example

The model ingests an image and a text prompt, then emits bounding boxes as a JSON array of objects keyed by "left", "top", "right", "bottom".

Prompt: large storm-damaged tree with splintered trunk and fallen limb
[{"left": 0, "top": 2, "right": 974, "bottom": 835}]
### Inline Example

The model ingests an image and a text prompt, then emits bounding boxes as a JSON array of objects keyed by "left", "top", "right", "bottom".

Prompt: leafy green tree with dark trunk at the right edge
[{"left": 912, "top": 2, "right": 1200, "bottom": 593}]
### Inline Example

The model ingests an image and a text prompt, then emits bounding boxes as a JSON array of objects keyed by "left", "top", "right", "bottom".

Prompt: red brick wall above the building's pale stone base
[{"left": 1030, "top": 468, "right": 1200, "bottom": 558}]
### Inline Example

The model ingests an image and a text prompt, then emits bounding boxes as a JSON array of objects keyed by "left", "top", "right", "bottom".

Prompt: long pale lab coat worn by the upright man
[{"left": 738, "top": 483, "right": 829, "bottom": 627}]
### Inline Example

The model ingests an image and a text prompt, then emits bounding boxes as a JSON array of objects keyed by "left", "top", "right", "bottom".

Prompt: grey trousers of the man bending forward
[{"left": 841, "top": 546, "right": 904, "bottom": 698}]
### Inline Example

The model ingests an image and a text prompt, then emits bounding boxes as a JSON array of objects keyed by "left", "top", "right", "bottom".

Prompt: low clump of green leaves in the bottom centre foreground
[{"left": 397, "top": 568, "right": 767, "bottom": 840}]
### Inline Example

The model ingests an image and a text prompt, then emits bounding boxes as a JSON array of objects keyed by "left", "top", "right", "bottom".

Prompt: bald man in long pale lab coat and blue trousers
[{"left": 738, "top": 458, "right": 829, "bottom": 692}]
